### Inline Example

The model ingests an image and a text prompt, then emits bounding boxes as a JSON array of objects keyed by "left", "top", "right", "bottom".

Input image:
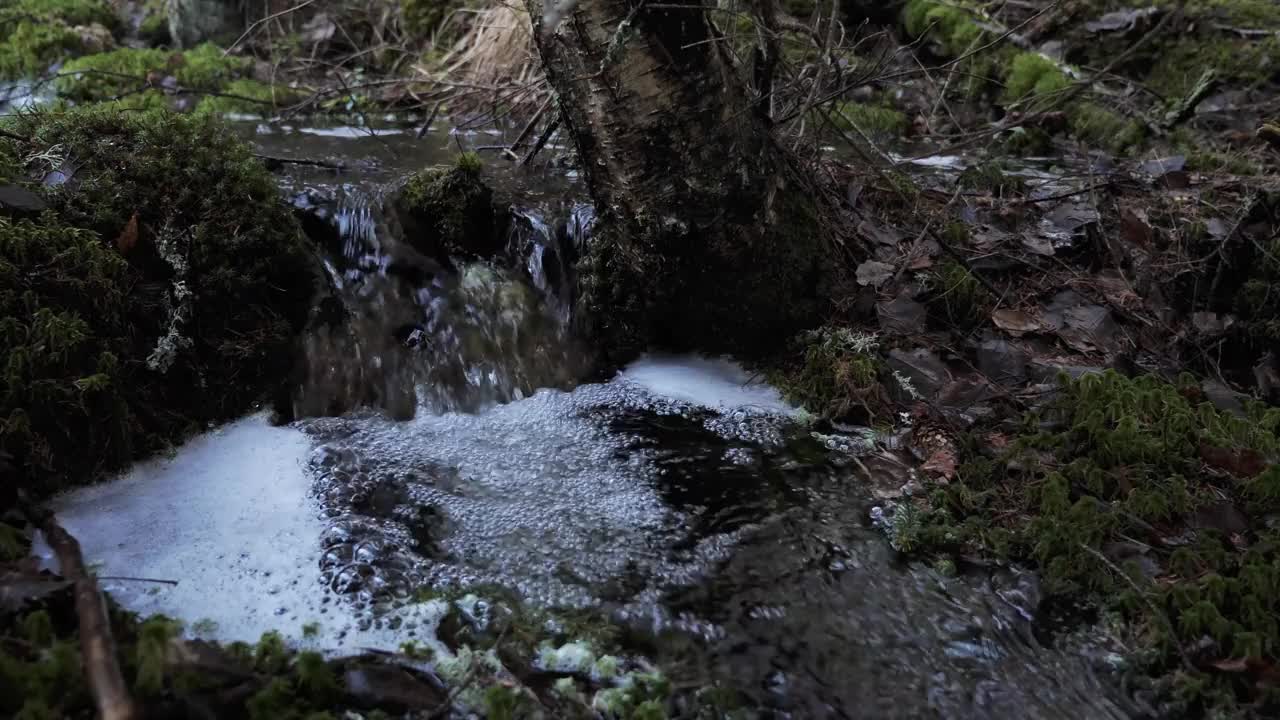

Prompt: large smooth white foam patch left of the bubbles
[{"left": 37, "top": 415, "right": 431, "bottom": 650}]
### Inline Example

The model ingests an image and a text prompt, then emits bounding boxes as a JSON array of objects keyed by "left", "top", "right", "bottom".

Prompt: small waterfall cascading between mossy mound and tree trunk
[{"left": 294, "top": 188, "right": 585, "bottom": 419}]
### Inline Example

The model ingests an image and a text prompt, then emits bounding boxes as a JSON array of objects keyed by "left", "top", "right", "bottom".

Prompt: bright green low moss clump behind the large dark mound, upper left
[{"left": 56, "top": 42, "right": 253, "bottom": 109}]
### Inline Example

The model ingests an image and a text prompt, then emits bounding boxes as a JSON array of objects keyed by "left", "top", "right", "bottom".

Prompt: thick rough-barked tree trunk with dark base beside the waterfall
[{"left": 527, "top": 0, "right": 829, "bottom": 360}]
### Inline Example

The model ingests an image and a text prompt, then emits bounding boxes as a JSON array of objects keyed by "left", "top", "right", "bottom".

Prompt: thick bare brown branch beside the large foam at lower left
[{"left": 40, "top": 514, "right": 140, "bottom": 720}]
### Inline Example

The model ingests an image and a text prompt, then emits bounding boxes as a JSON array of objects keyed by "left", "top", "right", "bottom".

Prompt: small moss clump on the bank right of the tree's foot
[{"left": 771, "top": 325, "right": 882, "bottom": 418}]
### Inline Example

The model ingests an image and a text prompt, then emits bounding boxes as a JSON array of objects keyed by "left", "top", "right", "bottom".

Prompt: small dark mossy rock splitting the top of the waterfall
[{"left": 392, "top": 152, "right": 504, "bottom": 264}]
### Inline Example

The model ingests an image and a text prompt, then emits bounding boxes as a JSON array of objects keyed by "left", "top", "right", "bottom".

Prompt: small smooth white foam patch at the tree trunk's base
[{"left": 618, "top": 355, "right": 796, "bottom": 415}]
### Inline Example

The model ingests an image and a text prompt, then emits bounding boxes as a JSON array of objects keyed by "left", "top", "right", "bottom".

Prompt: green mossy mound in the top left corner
[{"left": 0, "top": 0, "right": 120, "bottom": 79}]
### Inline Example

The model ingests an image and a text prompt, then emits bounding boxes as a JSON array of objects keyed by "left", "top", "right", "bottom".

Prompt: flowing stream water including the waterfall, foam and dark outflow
[{"left": 40, "top": 120, "right": 1138, "bottom": 719}]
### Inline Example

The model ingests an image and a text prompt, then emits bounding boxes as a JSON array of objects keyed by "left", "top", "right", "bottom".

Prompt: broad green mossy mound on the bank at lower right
[{"left": 918, "top": 372, "right": 1280, "bottom": 716}]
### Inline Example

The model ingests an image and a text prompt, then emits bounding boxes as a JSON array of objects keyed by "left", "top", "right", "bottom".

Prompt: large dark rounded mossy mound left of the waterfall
[{"left": 0, "top": 106, "right": 315, "bottom": 493}]
